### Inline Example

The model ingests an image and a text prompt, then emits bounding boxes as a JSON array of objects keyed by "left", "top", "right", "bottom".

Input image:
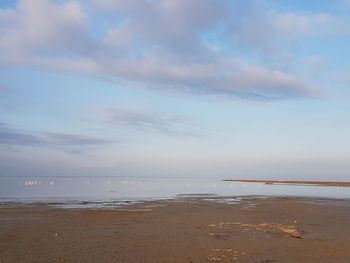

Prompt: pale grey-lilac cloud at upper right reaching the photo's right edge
[{"left": 229, "top": 11, "right": 350, "bottom": 52}]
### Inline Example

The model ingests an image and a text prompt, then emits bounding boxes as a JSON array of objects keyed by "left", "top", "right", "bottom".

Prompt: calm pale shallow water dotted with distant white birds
[{"left": 0, "top": 177, "right": 350, "bottom": 207}]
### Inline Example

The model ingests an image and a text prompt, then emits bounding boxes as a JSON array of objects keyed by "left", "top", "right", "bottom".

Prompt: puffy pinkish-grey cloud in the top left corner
[{"left": 0, "top": 0, "right": 89, "bottom": 56}]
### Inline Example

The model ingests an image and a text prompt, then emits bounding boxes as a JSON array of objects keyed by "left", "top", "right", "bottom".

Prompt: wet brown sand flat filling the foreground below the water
[{"left": 0, "top": 198, "right": 350, "bottom": 263}]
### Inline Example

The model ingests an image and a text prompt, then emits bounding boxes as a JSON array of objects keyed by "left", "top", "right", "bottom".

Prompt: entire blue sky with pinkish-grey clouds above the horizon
[{"left": 0, "top": 0, "right": 350, "bottom": 180}]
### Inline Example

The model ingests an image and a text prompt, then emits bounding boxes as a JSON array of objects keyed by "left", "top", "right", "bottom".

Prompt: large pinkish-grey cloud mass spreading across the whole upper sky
[{"left": 0, "top": 0, "right": 340, "bottom": 100}]
